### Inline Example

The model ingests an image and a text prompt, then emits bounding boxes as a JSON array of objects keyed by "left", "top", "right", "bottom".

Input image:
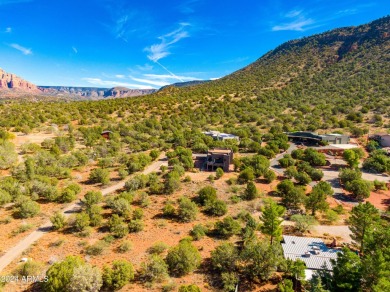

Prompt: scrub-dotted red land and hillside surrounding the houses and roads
[{"left": 0, "top": 17, "right": 390, "bottom": 291}]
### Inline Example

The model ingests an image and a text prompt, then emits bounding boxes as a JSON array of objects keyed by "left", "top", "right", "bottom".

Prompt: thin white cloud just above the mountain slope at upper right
[{"left": 272, "top": 9, "right": 315, "bottom": 31}]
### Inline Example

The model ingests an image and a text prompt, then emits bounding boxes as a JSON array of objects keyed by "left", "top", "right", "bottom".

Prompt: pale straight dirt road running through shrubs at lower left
[{"left": 0, "top": 153, "right": 168, "bottom": 272}]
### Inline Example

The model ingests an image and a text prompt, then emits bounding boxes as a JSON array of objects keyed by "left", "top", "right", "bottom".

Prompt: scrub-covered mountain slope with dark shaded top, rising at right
[{"left": 176, "top": 16, "right": 390, "bottom": 103}]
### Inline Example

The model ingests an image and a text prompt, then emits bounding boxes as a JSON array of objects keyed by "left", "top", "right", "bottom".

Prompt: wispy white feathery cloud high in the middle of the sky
[{"left": 144, "top": 22, "right": 190, "bottom": 62}]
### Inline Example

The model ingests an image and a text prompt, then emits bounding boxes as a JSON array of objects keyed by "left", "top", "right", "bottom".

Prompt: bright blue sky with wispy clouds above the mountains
[{"left": 0, "top": 0, "right": 390, "bottom": 88}]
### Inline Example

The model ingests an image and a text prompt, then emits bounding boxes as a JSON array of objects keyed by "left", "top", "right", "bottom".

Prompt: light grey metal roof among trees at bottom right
[{"left": 282, "top": 235, "right": 339, "bottom": 271}]
